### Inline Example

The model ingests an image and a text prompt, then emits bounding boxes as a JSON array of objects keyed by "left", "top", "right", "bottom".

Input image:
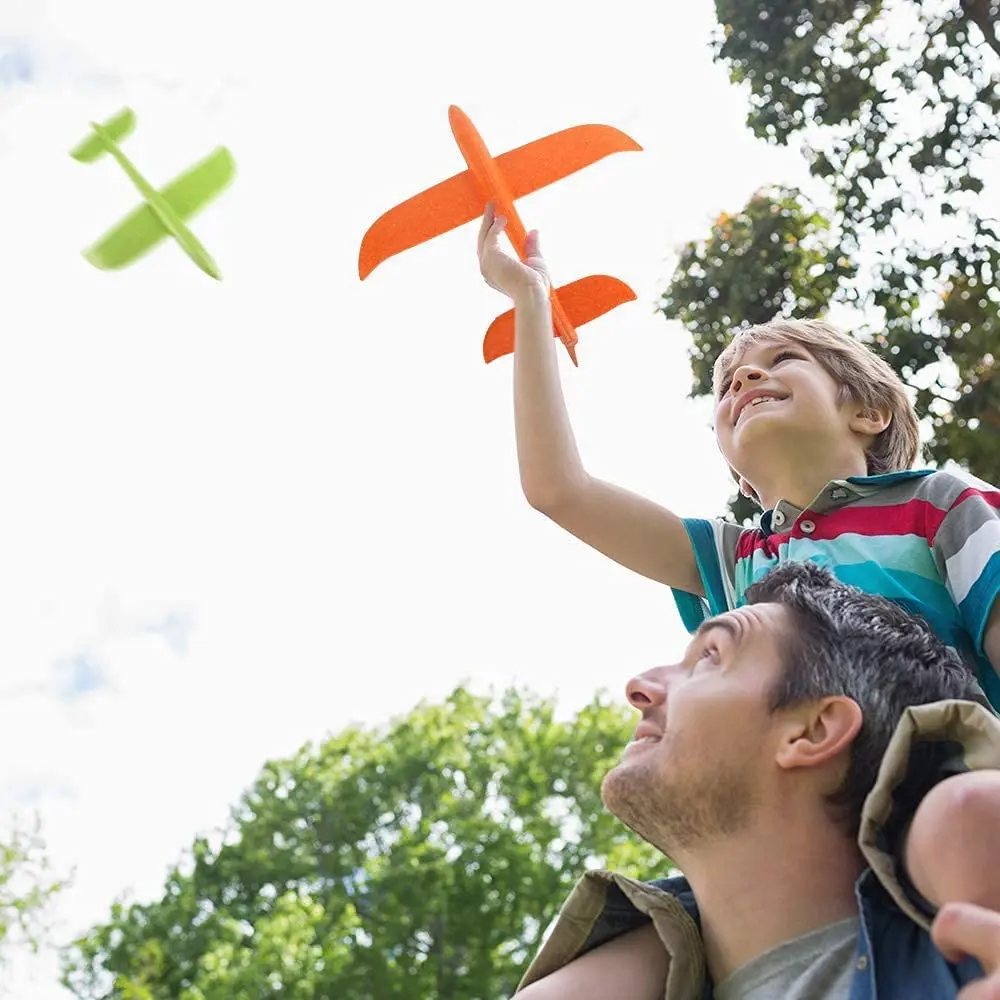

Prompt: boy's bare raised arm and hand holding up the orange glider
[{"left": 479, "top": 207, "right": 704, "bottom": 594}]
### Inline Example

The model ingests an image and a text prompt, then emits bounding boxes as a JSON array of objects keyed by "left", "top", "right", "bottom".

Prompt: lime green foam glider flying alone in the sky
[{"left": 69, "top": 108, "right": 236, "bottom": 280}]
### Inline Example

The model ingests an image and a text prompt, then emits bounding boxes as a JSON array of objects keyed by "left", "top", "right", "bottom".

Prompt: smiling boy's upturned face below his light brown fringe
[{"left": 715, "top": 339, "right": 857, "bottom": 485}]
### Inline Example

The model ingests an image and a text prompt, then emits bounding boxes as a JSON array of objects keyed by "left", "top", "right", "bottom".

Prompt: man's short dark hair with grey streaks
[{"left": 746, "top": 562, "right": 989, "bottom": 836}]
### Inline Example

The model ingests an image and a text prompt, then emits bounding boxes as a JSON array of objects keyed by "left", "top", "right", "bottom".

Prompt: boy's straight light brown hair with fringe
[{"left": 712, "top": 319, "right": 920, "bottom": 496}]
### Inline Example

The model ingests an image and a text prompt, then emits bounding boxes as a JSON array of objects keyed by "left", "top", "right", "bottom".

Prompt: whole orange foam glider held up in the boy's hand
[{"left": 358, "top": 105, "right": 642, "bottom": 364}]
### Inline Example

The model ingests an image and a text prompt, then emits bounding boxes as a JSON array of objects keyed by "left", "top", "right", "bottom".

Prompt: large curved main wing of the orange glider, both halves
[{"left": 358, "top": 125, "right": 642, "bottom": 280}]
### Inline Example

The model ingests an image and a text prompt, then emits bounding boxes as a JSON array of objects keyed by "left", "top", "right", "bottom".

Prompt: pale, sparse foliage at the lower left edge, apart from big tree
[{"left": 0, "top": 818, "right": 67, "bottom": 969}]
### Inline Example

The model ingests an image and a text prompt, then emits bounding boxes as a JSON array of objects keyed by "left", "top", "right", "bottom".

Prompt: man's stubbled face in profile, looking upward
[{"left": 601, "top": 604, "right": 790, "bottom": 855}]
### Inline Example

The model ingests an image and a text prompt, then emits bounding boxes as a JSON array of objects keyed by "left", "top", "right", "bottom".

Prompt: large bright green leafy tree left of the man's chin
[{"left": 64, "top": 688, "right": 666, "bottom": 1000}]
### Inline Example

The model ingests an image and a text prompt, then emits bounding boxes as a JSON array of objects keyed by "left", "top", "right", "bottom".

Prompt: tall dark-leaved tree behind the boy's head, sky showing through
[{"left": 662, "top": 0, "right": 1000, "bottom": 516}]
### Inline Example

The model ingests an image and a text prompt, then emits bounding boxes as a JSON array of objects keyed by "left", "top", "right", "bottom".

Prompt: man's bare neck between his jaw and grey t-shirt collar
[{"left": 677, "top": 817, "right": 865, "bottom": 983}]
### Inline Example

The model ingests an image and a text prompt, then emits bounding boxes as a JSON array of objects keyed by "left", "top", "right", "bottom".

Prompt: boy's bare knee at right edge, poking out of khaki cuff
[{"left": 905, "top": 770, "right": 1000, "bottom": 909}]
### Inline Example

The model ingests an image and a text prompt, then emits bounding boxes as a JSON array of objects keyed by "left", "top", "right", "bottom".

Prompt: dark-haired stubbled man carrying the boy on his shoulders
[{"left": 520, "top": 563, "right": 1000, "bottom": 1000}]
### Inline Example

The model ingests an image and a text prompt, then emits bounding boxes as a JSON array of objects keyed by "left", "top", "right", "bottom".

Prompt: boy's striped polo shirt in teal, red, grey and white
[{"left": 674, "top": 469, "right": 1000, "bottom": 710}]
